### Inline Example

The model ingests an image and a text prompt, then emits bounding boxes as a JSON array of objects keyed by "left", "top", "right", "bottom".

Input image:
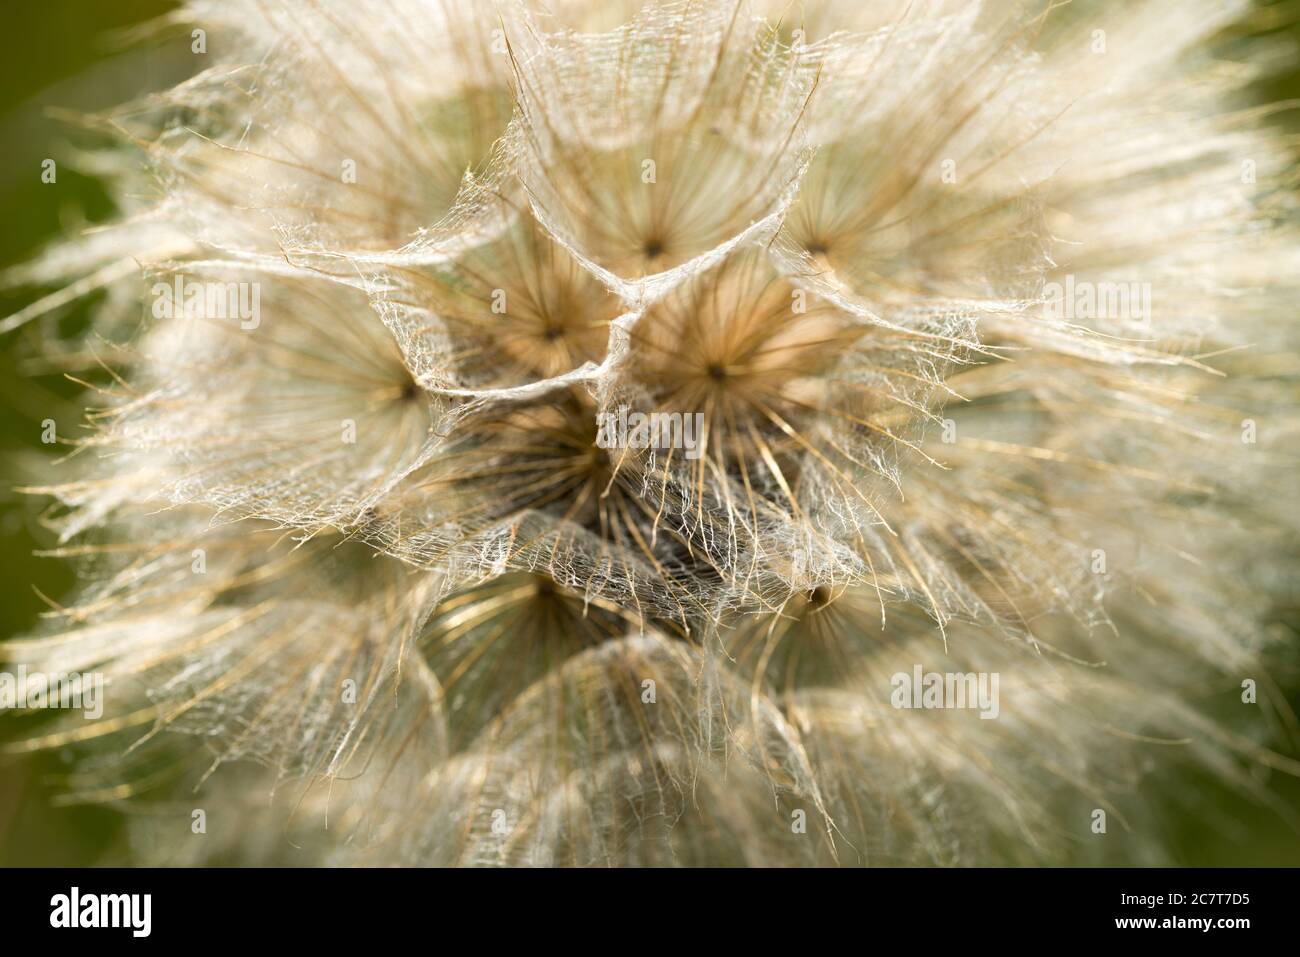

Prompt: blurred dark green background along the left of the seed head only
[{"left": 0, "top": 0, "right": 189, "bottom": 866}]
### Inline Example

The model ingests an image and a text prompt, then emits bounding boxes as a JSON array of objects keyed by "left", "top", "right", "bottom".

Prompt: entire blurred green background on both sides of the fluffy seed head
[{"left": 0, "top": 0, "right": 1300, "bottom": 866}]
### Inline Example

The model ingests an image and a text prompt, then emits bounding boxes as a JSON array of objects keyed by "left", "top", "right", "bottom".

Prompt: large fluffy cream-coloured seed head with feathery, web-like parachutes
[{"left": 4, "top": 0, "right": 1300, "bottom": 865}]
